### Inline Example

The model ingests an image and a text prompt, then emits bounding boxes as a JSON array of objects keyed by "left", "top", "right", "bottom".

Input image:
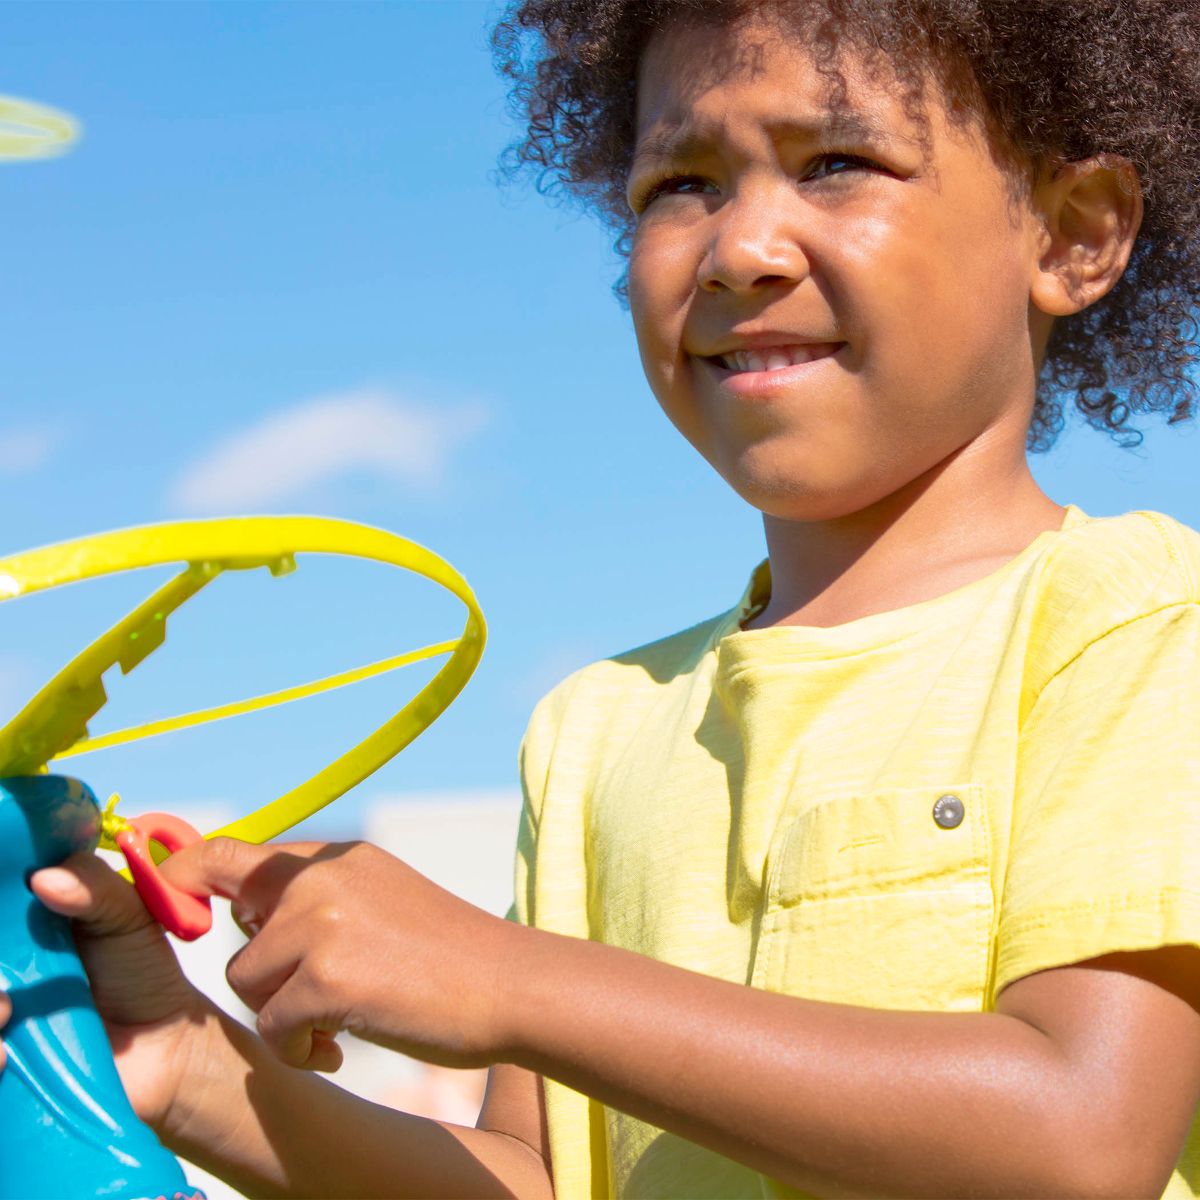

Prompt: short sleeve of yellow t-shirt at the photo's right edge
[{"left": 994, "top": 601, "right": 1200, "bottom": 996}]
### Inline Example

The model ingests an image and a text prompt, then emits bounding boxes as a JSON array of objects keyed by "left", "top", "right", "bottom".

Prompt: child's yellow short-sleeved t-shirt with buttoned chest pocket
[{"left": 510, "top": 505, "right": 1200, "bottom": 1200}]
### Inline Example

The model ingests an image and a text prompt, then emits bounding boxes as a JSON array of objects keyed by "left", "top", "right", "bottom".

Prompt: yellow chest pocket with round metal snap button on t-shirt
[{"left": 754, "top": 784, "right": 994, "bottom": 1012}]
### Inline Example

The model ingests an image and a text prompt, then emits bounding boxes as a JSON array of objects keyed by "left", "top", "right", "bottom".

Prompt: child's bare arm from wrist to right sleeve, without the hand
[{"left": 510, "top": 930, "right": 1200, "bottom": 1198}]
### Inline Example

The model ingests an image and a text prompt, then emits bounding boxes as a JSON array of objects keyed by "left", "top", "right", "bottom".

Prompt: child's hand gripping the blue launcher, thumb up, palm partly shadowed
[{"left": 0, "top": 854, "right": 209, "bottom": 1129}]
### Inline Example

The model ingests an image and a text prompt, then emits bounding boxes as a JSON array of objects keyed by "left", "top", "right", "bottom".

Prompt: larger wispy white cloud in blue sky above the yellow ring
[{"left": 169, "top": 389, "right": 487, "bottom": 512}]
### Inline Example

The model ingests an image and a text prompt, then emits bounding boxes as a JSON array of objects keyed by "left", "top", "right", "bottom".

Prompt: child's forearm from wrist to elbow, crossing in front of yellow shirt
[{"left": 501, "top": 930, "right": 1115, "bottom": 1200}]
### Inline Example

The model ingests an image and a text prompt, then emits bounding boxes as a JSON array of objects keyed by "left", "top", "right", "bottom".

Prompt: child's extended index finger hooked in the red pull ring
[{"left": 158, "top": 838, "right": 325, "bottom": 916}]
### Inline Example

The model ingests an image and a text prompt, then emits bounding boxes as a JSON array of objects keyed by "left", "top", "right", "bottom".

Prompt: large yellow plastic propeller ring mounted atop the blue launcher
[{"left": 0, "top": 517, "right": 487, "bottom": 850}]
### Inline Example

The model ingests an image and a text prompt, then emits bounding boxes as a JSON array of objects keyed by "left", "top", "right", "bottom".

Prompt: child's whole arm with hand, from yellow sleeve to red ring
[{"left": 162, "top": 839, "right": 1200, "bottom": 1200}]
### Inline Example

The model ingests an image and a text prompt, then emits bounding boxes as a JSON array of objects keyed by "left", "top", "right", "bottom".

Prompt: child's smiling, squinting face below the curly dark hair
[{"left": 629, "top": 11, "right": 1052, "bottom": 521}]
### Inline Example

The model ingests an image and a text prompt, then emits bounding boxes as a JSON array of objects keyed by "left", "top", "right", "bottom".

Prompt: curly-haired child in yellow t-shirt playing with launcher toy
[{"left": 7, "top": 0, "right": 1200, "bottom": 1198}]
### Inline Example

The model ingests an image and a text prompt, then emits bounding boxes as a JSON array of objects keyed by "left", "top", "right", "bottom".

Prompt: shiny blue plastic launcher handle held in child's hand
[{"left": 0, "top": 775, "right": 203, "bottom": 1200}]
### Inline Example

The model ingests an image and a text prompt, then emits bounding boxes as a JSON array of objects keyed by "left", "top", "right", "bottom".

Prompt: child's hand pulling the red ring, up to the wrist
[{"left": 161, "top": 838, "right": 524, "bottom": 1070}]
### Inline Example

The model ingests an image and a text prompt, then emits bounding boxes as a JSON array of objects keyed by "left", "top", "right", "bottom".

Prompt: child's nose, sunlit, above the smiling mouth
[{"left": 696, "top": 194, "right": 809, "bottom": 293}]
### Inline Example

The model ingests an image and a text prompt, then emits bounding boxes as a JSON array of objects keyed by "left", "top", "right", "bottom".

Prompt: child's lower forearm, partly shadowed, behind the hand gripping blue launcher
[{"left": 160, "top": 1008, "right": 553, "bottom": 1200}]
